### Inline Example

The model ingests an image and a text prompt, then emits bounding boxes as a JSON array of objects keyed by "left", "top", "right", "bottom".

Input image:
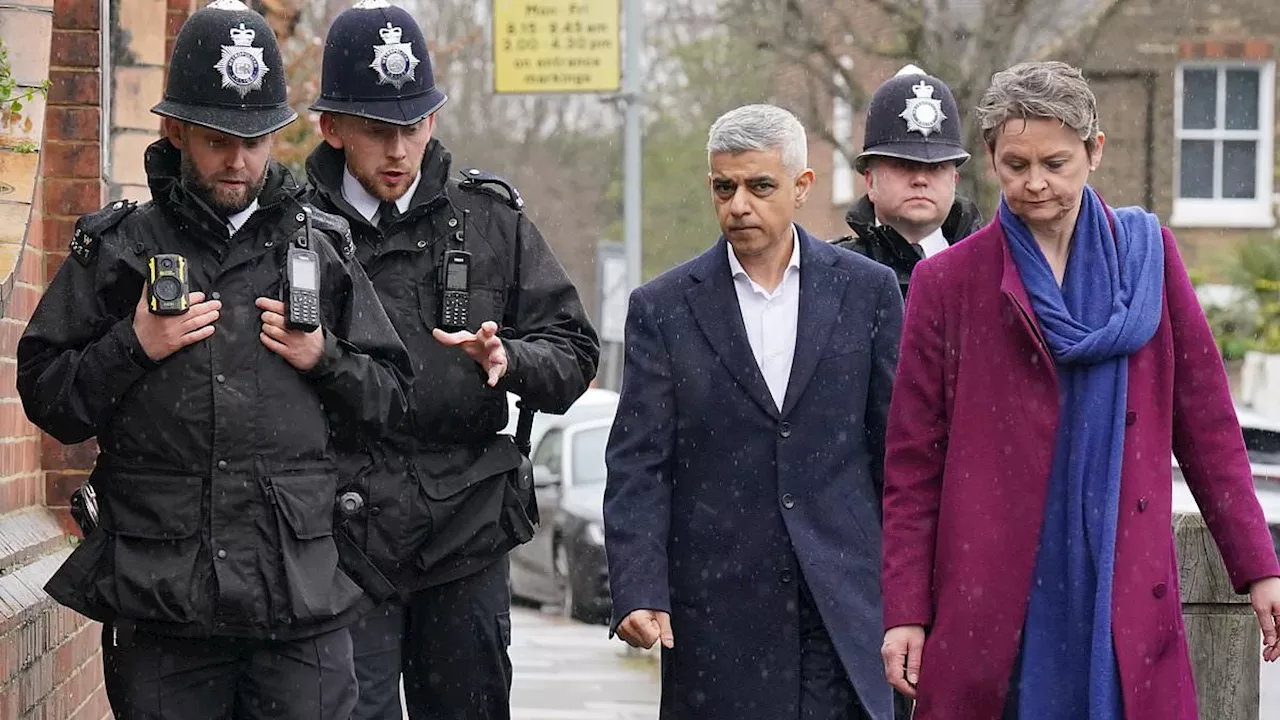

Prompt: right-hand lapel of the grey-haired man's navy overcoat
[{"left": 782, "top": 229, "right": 849, "bottom": 416}]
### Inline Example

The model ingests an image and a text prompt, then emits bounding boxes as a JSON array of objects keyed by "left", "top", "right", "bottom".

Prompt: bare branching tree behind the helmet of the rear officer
[{"left": 717, "top": 0, "right": 1126, "bottom": 197}]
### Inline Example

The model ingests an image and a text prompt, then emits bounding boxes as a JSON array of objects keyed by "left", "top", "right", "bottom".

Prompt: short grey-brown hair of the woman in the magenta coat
[{"left": 978, "top": 60, "right": 1098, "bottom": 152}]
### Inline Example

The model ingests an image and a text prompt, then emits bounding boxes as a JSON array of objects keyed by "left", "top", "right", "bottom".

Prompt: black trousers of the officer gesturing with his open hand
[{"left": 351, "top": 557, "right": 511, "bottom": 720}]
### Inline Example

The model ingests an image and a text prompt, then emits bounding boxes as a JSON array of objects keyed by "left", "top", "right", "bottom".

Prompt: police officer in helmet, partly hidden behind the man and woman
[{"left": 836, "top": 65, "right": 983, "bottom": 297}]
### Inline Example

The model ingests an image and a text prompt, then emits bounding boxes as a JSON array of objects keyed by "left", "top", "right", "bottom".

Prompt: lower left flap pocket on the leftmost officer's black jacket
[{"left": 99, "top": 474, "right": 204, "bottom": 623}]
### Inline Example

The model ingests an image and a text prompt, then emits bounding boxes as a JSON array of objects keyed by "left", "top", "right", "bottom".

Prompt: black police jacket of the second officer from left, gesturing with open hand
[{"left": 307, "top": 140, "right": 600, "bottom": 591}]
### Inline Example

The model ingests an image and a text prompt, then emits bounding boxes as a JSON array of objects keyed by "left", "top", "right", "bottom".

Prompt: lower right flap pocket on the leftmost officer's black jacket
[{"left": 266, "top": 474, "right": 361, "bottom": 624}]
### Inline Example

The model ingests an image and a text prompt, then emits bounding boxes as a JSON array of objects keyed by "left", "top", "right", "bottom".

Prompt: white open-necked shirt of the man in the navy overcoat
[{"left": 728, "top": 225, "right": 800, "bottom": 410}]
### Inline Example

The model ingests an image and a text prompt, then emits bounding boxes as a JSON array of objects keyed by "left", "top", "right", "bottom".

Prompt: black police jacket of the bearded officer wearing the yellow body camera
[{"left": 18, "top": 140, "right": 411, "bottom": 638}]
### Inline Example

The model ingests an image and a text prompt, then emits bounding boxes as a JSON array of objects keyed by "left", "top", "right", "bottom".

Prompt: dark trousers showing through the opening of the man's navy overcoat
[{"left": 800, "top": 583, "right": 870, "bottom": 720}]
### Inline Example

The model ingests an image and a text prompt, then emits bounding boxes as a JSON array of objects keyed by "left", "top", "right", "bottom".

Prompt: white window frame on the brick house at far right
[{"left": 1169, "top": 60, "right": 1276, "bottom": 228}]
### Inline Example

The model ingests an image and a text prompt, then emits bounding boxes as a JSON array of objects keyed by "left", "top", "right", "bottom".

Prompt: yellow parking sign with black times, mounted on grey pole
[{"left": 493, "top": 0, "right": 622, "bottom": 94}]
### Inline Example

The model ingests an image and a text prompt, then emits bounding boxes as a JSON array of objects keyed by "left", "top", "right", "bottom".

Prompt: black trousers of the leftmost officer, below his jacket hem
[{"left": 102, "top": 625, "right": 356, "bottom": 720}]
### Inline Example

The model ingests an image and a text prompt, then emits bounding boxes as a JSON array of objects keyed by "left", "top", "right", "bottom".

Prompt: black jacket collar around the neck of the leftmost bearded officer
[{"left": 145, "top": 138, "right": 300, "bottom": 238}]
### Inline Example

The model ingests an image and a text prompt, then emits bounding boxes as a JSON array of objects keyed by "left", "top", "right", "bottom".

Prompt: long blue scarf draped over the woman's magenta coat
[{"left": 1000, "top": 187, "right": 1165, "bottom": 720}]
